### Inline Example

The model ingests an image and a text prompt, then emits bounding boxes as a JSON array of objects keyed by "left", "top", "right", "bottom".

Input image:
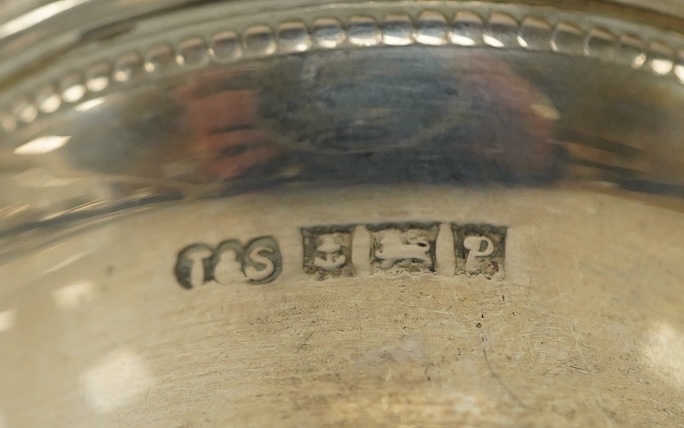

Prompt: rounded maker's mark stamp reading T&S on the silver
[{"left": 174, "top": 237, "right": 283, "bottom": 290}]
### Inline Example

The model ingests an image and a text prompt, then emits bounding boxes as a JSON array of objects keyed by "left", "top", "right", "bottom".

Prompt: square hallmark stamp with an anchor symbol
[{"left": 301, "top": 226, "right": 356, "bottom": 280}]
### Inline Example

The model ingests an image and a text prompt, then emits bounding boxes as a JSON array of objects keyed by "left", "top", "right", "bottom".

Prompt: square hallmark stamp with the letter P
[{"left": 451, "top": 224, "right": 508, "bottom": 279}]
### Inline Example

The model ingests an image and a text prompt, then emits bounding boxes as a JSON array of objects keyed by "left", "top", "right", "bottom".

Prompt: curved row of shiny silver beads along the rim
[{"left": 0, "top": 5, "right": 684, "bottom": 133}]
